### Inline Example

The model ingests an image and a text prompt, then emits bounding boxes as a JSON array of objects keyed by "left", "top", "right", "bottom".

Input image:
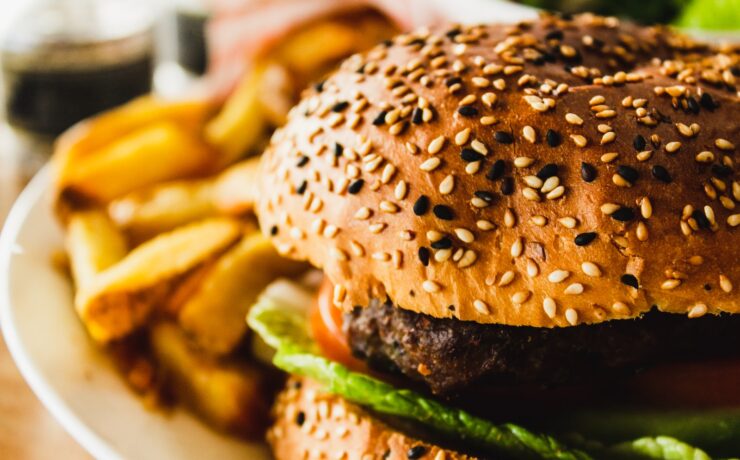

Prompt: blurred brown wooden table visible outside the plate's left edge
[{"left": 0, "top": 124, "right": 90, "bottom": 460}]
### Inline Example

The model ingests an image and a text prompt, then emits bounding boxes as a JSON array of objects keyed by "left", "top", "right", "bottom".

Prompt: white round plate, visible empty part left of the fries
[{"left": 0, "top": 168, "right": 269, "bottom": 460}]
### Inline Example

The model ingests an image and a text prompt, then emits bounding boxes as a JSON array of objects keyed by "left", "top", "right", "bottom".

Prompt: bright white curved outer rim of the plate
[{"left": 0, "top": 168, "right": 123, "bottom": 459}]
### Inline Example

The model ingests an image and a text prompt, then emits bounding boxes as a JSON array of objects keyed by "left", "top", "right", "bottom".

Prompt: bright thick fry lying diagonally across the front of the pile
[{"left": 75, "top": 218, "right": 241, "bottom": 342}]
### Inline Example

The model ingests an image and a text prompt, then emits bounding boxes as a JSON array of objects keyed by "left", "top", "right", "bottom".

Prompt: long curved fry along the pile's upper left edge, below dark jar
[{"left": 52, "top": 96, "right": 214, "bottom": 211}]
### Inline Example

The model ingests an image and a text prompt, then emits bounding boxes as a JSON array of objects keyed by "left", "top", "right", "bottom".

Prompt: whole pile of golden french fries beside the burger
[{"left": 52, "top": 13, "right": 393, "bottom": 436}]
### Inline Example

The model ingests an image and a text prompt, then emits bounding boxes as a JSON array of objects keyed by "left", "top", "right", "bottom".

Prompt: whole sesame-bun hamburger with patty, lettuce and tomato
[{"left": 248, "top": 14, "right": 740, "bottom": 459}]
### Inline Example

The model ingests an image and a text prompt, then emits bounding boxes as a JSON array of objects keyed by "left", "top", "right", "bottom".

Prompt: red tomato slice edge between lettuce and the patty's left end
[{"left": 309, "top": 279, "right": 365, "bottom": 370}]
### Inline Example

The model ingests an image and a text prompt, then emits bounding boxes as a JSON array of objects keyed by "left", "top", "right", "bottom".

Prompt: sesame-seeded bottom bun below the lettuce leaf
[{"left": 267, "top": 378, "right": 475, "bottom": 460}]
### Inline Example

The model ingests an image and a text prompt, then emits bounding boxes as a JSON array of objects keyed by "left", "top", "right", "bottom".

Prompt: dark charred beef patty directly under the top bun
[{"left": 344, "top": 301, "right": 740, "bottom": 394}]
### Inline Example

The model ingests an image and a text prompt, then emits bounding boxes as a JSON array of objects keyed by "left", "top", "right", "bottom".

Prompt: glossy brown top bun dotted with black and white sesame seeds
[{"left": 258, "top": 15, "right": 740, "bottom": 327}]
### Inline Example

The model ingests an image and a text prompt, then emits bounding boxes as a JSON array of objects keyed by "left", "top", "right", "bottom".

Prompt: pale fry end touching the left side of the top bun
[{"left": 212, "top": 157, "right": 260, "bottom": 214}]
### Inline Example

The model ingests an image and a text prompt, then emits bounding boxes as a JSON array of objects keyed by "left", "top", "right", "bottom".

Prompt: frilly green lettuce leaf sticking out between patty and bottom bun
[{"left": 247, "top": 296, "right": 710, "bottom": 460}]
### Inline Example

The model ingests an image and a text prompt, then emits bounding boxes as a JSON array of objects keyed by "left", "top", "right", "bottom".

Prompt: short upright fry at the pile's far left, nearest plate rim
[{"left": 65, "top": 210, "right": 128, "bottom": 289}]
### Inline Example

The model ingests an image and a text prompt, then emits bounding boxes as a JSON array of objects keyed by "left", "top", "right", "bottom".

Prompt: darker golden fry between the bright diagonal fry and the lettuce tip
[{"left": 178, "top": 232, "right": 306, "bottom": 355}]
